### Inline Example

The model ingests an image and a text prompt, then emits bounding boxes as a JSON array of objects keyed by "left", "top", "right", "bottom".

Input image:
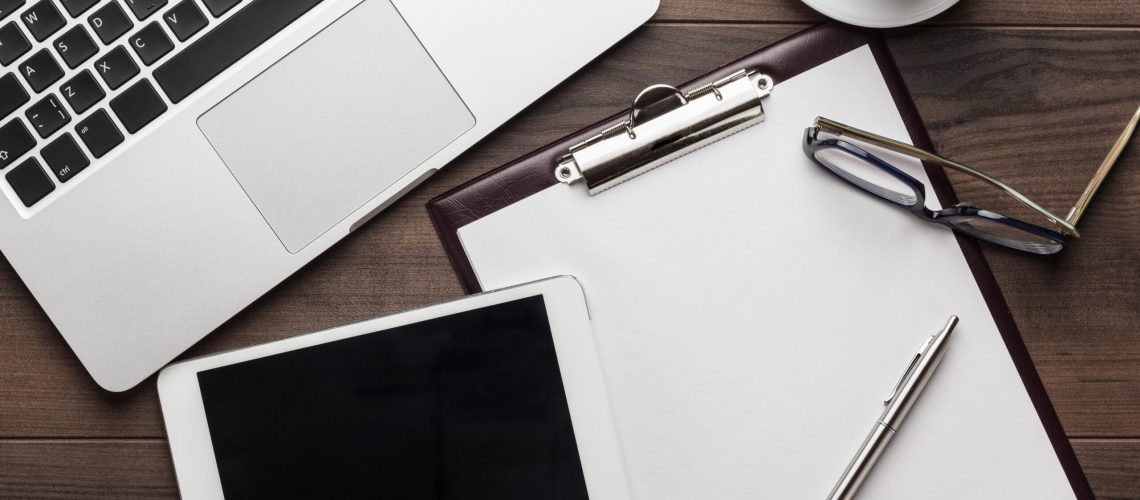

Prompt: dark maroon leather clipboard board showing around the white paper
[{"left": 428, "top": 23, "right": 1094, "bottom": 499}]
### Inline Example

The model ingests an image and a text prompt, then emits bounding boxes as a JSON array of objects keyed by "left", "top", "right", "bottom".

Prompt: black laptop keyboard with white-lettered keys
[{"left": 0, "top": 0, "right": 321, "bottom": 207}]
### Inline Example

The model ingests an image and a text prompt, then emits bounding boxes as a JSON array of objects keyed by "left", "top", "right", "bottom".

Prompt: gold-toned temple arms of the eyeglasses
[{"left": 815, "top": 107, "right": 1140, "bottom": 238}]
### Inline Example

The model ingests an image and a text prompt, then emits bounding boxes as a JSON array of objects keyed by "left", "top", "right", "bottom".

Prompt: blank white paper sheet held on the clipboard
[{"left": 459, "top": 47, "right": 1074, "bottom": 500}]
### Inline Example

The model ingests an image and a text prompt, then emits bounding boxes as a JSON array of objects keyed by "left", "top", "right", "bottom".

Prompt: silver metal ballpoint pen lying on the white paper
[{"left": 828, "top": 315, "right": 958, "bottom": 500}]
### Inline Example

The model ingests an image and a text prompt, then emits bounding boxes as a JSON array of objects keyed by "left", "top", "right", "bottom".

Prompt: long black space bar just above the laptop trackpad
[{"left": 154, "top": 0, "right": 320, "bottom": 103}]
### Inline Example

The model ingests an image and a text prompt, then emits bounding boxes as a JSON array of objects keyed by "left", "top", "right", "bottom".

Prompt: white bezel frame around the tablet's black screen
[{"left": 158, "top": 277, "right": 629, "bottom": 500}]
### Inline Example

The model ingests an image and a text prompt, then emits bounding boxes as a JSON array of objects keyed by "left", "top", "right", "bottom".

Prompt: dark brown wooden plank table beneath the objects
[{"left": 0, "top": 0, "right": 1140, "bottom": 499}]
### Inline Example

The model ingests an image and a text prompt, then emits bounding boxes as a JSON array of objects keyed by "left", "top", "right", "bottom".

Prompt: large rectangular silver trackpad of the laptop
[{"left": 198, "top": 0, "right": 475, "bottom": 253}]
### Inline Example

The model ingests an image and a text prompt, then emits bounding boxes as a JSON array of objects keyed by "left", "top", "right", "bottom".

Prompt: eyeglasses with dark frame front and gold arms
[{"left": 804, "top": 108, "right": 1140, "bottom": 255}]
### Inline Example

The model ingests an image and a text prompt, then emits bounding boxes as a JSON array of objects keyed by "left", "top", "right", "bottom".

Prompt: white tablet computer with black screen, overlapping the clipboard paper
[{"left": 158, "top": 278, "right": 628, "bottom": 500}]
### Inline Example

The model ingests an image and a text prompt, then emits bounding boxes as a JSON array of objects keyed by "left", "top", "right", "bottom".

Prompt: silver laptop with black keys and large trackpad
[{"left": 0, "top": 0, "right": 658, "bottom": 391}]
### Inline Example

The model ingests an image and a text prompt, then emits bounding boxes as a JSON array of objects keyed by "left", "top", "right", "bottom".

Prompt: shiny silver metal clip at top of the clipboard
[{"left": 554, "top": 69, "right": 774, "bottom": 195}]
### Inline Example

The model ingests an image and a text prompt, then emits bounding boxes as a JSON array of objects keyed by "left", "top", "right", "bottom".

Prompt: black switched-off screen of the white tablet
[{"left": 198, "top": 295, "right": 587, "bottom": 499}]
